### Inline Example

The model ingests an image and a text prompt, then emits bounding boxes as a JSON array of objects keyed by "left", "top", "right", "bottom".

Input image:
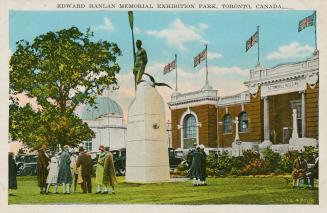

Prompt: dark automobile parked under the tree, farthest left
[{"left": 16, "top": 155, "right": 37, "bottom": 176}]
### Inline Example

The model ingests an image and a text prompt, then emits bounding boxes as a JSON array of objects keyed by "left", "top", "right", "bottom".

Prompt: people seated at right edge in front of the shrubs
[{"left": 292, "top": 153, "right": 319, "bottom": 188}]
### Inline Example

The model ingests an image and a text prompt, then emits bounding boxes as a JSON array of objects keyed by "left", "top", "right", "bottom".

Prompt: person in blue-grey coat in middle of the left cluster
[{"left": 57, "top": 145, "right": 72, "bottom": 194}]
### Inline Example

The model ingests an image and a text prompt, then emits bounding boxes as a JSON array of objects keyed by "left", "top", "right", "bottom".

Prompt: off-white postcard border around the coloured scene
[{"left": 0, "top": 0, "right": 327, "bottom": 213}]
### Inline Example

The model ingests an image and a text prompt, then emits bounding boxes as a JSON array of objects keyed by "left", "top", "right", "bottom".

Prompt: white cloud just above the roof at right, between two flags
[{"left": 266, "top": 42, "right": 314, "bottom": 60}]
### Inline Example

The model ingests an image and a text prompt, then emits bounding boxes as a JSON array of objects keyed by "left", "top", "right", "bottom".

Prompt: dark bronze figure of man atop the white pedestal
[{"left": 133, "top": 40, "right": 148, "bottom": 84}]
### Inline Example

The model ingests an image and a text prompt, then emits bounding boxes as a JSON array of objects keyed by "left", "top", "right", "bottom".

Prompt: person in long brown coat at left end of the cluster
[{"left": 37, "top": 144, "right": 49, "bottom": 194}]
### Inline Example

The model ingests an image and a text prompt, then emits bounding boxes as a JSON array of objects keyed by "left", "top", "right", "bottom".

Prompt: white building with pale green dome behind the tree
[{"left": 81, "top": 96, "right": 126, "bottom": 152}]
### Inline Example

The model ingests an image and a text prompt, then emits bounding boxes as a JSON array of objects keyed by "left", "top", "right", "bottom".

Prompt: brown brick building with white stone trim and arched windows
[{"left": 168, "top": 52, "right": 319, "bottom": 153}]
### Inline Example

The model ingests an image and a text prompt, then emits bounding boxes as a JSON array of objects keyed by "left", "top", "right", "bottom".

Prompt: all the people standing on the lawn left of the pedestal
[{"left": 8, "top": 145, "right": 117, "bottom": 195}]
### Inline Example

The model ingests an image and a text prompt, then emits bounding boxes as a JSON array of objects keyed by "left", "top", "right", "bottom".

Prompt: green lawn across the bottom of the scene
[{"left": 9, "top": 177, "right": 318, "bottom": 205}]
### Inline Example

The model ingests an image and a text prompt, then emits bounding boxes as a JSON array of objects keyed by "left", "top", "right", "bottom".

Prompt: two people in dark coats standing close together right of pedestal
[{"left": 187, "top": 144, "right": 207, "bottom": 186}]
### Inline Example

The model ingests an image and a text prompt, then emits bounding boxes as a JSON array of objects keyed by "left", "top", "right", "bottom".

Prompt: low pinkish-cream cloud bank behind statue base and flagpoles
[{"left": 110, "top": 63, "right": 249, "bottom": 121}]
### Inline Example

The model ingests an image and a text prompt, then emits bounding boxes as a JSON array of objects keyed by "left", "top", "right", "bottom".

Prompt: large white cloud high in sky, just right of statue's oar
[{"left": 146, "top": 18, "right": 208, "bottom": 50}]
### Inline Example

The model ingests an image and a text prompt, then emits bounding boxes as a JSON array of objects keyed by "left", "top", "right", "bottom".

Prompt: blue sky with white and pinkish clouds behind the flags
[{"left": 9, "top": 10, "right": 319, "bottom": 120}]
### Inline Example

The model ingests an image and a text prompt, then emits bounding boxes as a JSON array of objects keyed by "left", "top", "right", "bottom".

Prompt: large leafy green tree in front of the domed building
[{"left": 9, "top": 27, "right": 121, "bottom": 149}]
